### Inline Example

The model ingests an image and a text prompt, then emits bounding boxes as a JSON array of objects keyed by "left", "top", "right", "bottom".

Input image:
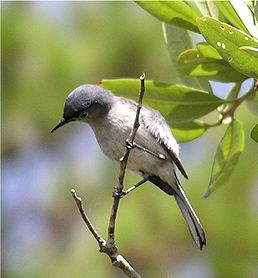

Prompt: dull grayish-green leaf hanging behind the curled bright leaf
[{"left": 162, "top": 23, "right": 211, "bottom": 92}]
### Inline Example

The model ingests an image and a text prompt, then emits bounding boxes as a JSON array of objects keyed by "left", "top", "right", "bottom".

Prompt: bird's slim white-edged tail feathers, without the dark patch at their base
[{"left": 174, "top": 186, "right": 206, "bottom": 250}]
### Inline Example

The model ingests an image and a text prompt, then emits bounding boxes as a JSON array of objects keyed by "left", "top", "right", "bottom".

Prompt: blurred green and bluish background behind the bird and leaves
[{"left": 2, "top": 2, "right": 258, "bottom": 278}]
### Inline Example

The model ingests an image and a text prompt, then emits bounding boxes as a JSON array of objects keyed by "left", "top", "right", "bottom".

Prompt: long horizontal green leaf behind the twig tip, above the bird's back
[{"left": 100, "top": 79, "right": 225, "bottom": 124}]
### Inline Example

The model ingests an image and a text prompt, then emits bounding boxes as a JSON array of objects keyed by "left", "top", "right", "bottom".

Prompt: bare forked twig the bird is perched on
[{"left": 71, "top": 73, "right": 146, "bottom": 278}]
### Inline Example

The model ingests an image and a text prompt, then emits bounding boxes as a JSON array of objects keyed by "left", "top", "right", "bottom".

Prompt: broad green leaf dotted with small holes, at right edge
[{"left": 197, "top": 17, "right": 258, "bottom": 78}]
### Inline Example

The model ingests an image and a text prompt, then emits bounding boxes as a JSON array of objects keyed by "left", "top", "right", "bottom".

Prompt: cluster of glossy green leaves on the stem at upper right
[{"left": 101, "top": 0, "right": 258, "bottom": 197}]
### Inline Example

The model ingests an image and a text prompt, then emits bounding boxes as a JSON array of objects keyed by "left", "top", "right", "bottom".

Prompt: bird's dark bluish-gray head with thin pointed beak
[{"left": 51, "top": 84, "right": 114, "bottom": 132}]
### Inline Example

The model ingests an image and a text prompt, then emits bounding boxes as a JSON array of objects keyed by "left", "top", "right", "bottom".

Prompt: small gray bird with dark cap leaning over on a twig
[{"left": 51, "top": 85, "right": 206, "bottom": 249}]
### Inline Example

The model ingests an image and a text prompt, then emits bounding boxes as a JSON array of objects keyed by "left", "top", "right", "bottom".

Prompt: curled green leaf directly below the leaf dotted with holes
[{"left": 178, "top": 49, "right": 246, "bottom": 82}]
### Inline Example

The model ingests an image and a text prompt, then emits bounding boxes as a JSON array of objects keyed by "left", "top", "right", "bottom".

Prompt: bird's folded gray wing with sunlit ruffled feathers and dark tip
[{"left": 141, "top": 107, "right": 188, "bottom": 179}]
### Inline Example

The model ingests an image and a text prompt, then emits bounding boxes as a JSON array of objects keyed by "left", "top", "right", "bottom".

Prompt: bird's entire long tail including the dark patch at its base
[{"left": 149, "top": 175, "right": 206, "bottom": 250}]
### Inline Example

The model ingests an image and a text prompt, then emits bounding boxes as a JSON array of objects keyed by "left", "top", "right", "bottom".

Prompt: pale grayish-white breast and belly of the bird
[{"left": 91, "top": 100, "right": 173, "bottom": 178}]
